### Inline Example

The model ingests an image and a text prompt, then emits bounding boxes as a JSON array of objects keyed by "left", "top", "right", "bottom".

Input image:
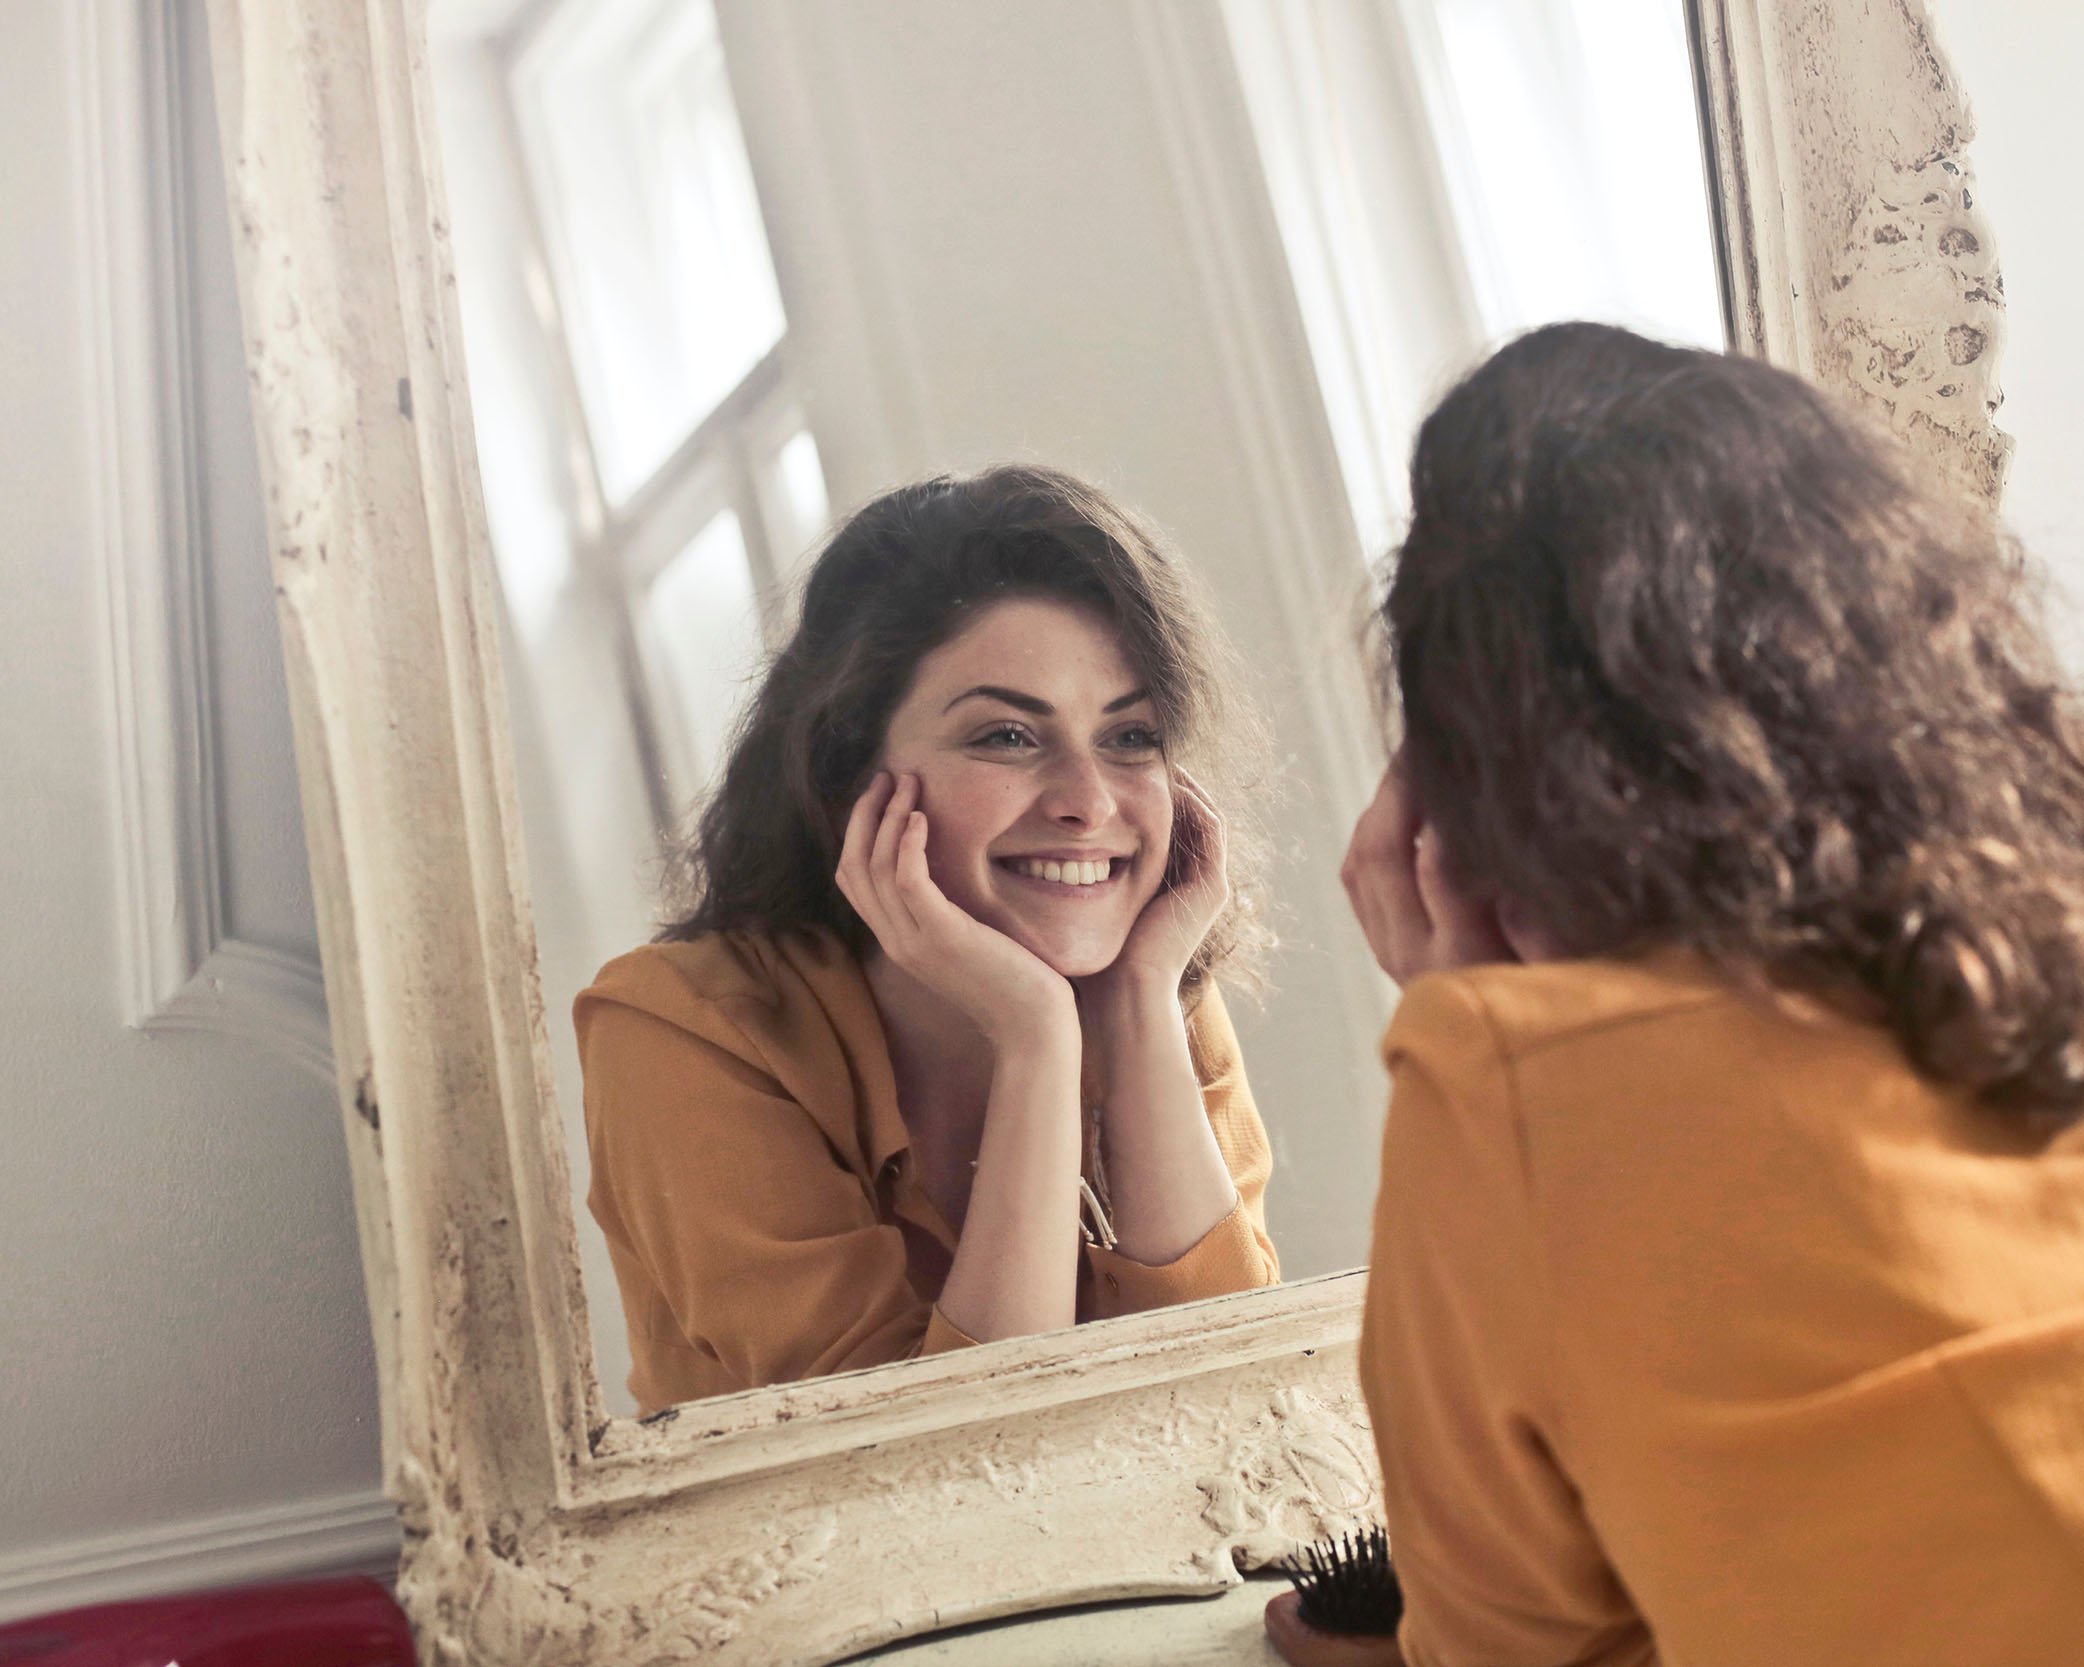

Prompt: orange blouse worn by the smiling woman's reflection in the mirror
[{"left": 573, "top": 931, "right": 1280, "bottom": 1413}]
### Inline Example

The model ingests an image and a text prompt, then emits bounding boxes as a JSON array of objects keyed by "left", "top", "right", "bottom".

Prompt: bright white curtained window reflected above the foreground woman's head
[{"left": 1223, "top": 0, "right": 1723, "bottom": 554}]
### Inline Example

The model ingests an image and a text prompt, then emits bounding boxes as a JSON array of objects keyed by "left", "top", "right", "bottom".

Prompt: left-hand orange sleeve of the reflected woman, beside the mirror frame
[{"left": 575, "top": 998, "right": 971, "bottom": 1411}]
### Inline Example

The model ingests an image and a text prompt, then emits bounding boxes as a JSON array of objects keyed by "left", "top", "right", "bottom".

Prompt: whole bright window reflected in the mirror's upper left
[{"left": 442, "top": 0, "right": 827, "bottom": 831}]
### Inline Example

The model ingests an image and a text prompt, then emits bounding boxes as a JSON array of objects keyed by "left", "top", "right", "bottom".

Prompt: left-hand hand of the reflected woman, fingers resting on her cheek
[{"left": 834, "top": 771, "right": 1077, "bottom": 1046}]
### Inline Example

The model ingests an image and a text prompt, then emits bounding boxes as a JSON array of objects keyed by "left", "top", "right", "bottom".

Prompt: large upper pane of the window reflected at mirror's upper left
[{"left": 515, "top": 0, "right": 784, "bottom": 504}]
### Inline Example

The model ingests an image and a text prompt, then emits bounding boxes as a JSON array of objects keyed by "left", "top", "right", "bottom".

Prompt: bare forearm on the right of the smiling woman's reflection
[{"left": 1084, "top": 979, "right": 1238, "bottom": 1267}]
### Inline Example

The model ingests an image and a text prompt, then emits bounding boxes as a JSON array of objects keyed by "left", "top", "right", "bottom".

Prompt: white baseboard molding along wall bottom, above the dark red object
[{"left": 0, "top": 1490, "right": 398, "bottom": 1621}]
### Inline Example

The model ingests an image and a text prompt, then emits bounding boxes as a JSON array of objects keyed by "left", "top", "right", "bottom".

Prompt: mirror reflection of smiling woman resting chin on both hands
[{"left": 575, "top": 467, "right": 1280, "bottom": 1411}]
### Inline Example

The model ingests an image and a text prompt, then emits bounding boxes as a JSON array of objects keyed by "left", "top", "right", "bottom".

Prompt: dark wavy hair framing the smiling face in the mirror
[{"left": 659, "top": 465, "right": 1271, "bottom": 1004}]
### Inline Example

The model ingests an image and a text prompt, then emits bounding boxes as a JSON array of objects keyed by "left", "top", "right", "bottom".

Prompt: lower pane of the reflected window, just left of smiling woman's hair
[{"left": 638, "top": 511, "right": 761, "bottom": 804}]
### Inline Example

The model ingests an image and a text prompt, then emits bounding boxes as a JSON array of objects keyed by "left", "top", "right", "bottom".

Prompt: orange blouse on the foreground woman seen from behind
[{"left": 1361, "top": 954, "right": 2084, "bottom": 1667}]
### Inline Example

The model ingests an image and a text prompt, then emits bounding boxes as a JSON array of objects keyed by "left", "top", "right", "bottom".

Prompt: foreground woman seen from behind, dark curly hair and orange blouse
[{"left": 1344, "top": 325, "right": 2084, "bottom": 1667}]
